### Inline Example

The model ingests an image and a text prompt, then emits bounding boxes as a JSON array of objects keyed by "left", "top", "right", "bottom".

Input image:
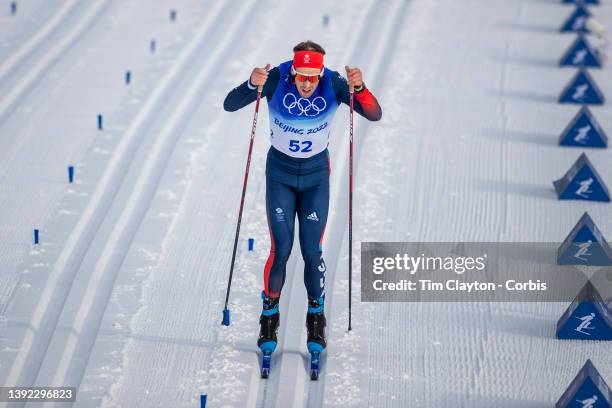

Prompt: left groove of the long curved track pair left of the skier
[{"left": 7, "top": 0, "right": 233, "bottom": 396}]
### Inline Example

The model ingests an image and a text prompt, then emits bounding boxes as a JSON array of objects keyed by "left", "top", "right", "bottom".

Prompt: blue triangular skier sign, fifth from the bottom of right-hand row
[{"left": 559, "top": 106, "right": 608, "bottom": 148}]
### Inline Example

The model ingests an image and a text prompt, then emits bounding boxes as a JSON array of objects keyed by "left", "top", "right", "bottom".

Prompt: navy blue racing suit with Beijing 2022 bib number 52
[{"left": 223, "top": 61, "right": 382, "bottom": 299}]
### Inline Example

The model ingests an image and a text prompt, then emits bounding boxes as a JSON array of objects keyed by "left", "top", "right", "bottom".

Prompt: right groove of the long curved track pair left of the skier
[{"left": 33, "top": 2, "right": 262, "bottom": 404}]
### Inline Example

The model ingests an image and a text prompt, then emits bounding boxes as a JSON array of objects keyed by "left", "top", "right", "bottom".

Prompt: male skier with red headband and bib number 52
[{"left": 223, "top": 41, "right": 382, "bottom": 377}]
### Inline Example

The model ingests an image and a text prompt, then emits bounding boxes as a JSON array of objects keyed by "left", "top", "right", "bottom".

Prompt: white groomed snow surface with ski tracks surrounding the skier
[{"left": 0, "top": 0, "right": 612, "bottom": 408}]
